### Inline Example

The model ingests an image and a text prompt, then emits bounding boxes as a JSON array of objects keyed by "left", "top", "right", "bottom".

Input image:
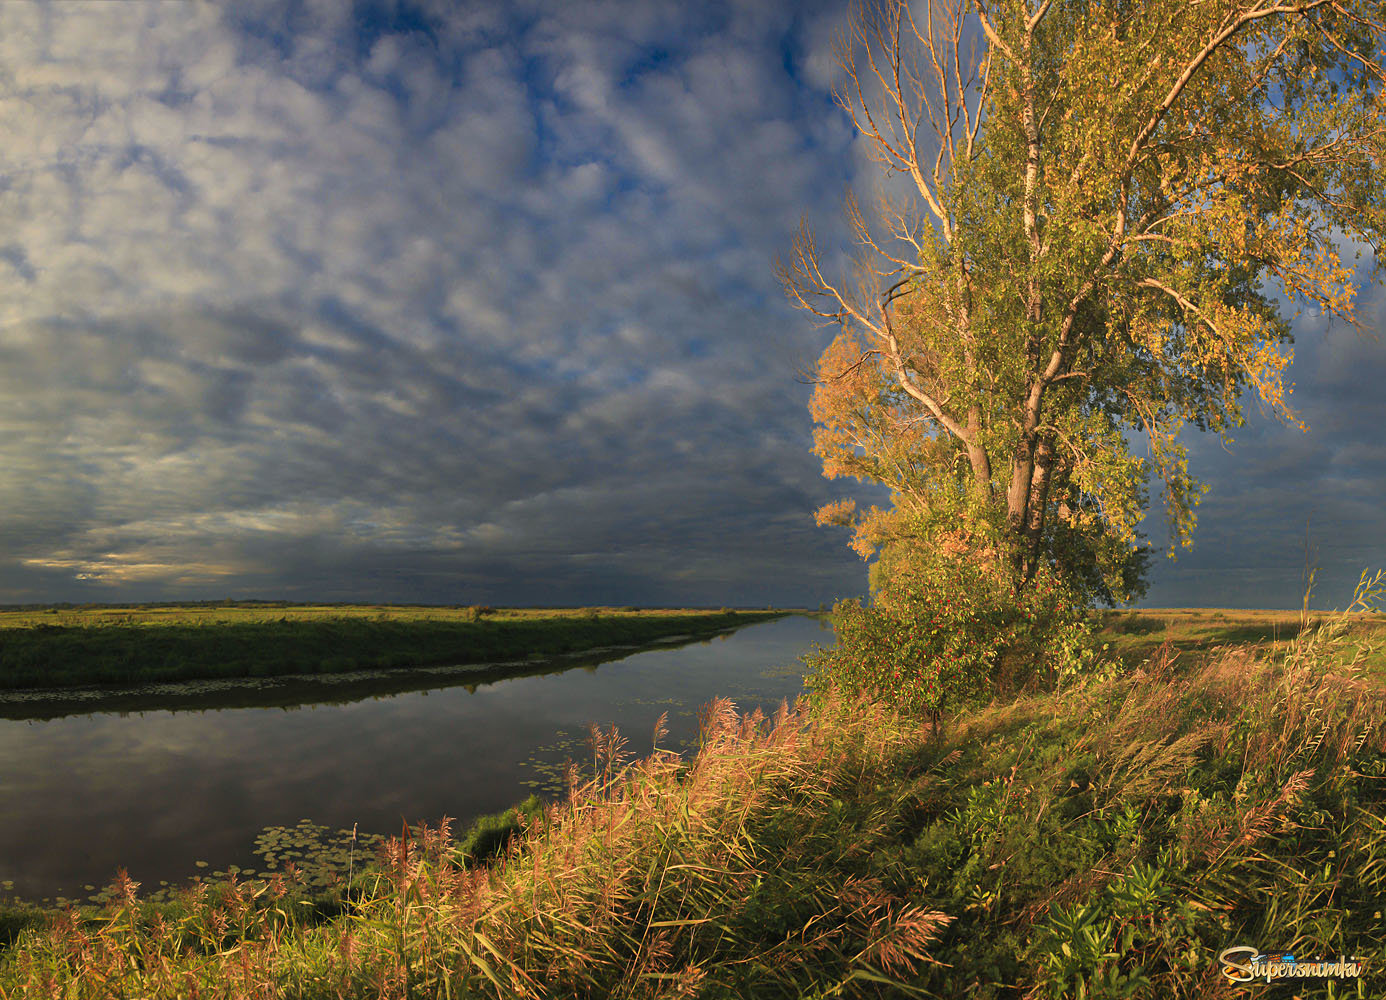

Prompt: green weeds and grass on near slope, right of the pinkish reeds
[{"left": 853, "top": 579, "right": 1386, "bottom": 1000}]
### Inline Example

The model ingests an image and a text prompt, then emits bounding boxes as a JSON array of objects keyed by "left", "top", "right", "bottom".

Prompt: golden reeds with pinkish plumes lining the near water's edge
[{"left": 0, "top": 689, "right": 948, "bottom": 1000}]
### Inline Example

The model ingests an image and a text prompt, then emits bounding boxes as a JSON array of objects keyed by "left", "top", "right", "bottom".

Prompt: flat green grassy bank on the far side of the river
[{"left": 0, "top": 605, "right": 784, "bottom": 690}]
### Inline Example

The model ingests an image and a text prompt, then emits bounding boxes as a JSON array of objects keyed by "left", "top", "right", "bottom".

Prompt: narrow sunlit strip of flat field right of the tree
[{"left": 1102, "top": 608, "right": 1386, "bottom": 676}]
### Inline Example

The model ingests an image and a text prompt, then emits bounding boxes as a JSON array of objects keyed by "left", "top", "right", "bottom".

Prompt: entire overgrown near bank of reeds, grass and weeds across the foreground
[{"left": 0, "top": 606, "right": 1386, "bottom": 1000}]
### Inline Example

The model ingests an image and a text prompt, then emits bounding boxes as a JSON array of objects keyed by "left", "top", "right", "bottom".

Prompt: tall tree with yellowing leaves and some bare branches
[{"left": 778, "top": 0, "right": 1386, "bottom": 600}]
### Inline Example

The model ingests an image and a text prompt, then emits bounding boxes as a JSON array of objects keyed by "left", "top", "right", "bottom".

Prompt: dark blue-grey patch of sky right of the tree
[{"left": 1145, "top": 277, "right": 1386, "bottom": 609}]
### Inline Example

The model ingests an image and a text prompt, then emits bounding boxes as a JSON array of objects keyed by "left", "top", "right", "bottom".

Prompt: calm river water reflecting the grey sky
[{"left": 0, "top": 616, "right": 832, "bottom": 899}]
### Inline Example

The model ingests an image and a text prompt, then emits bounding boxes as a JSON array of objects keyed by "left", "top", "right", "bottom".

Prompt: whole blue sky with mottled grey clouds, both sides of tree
[{"left": 0, "top": 0, "right": 1386, "bottom": 607}]
